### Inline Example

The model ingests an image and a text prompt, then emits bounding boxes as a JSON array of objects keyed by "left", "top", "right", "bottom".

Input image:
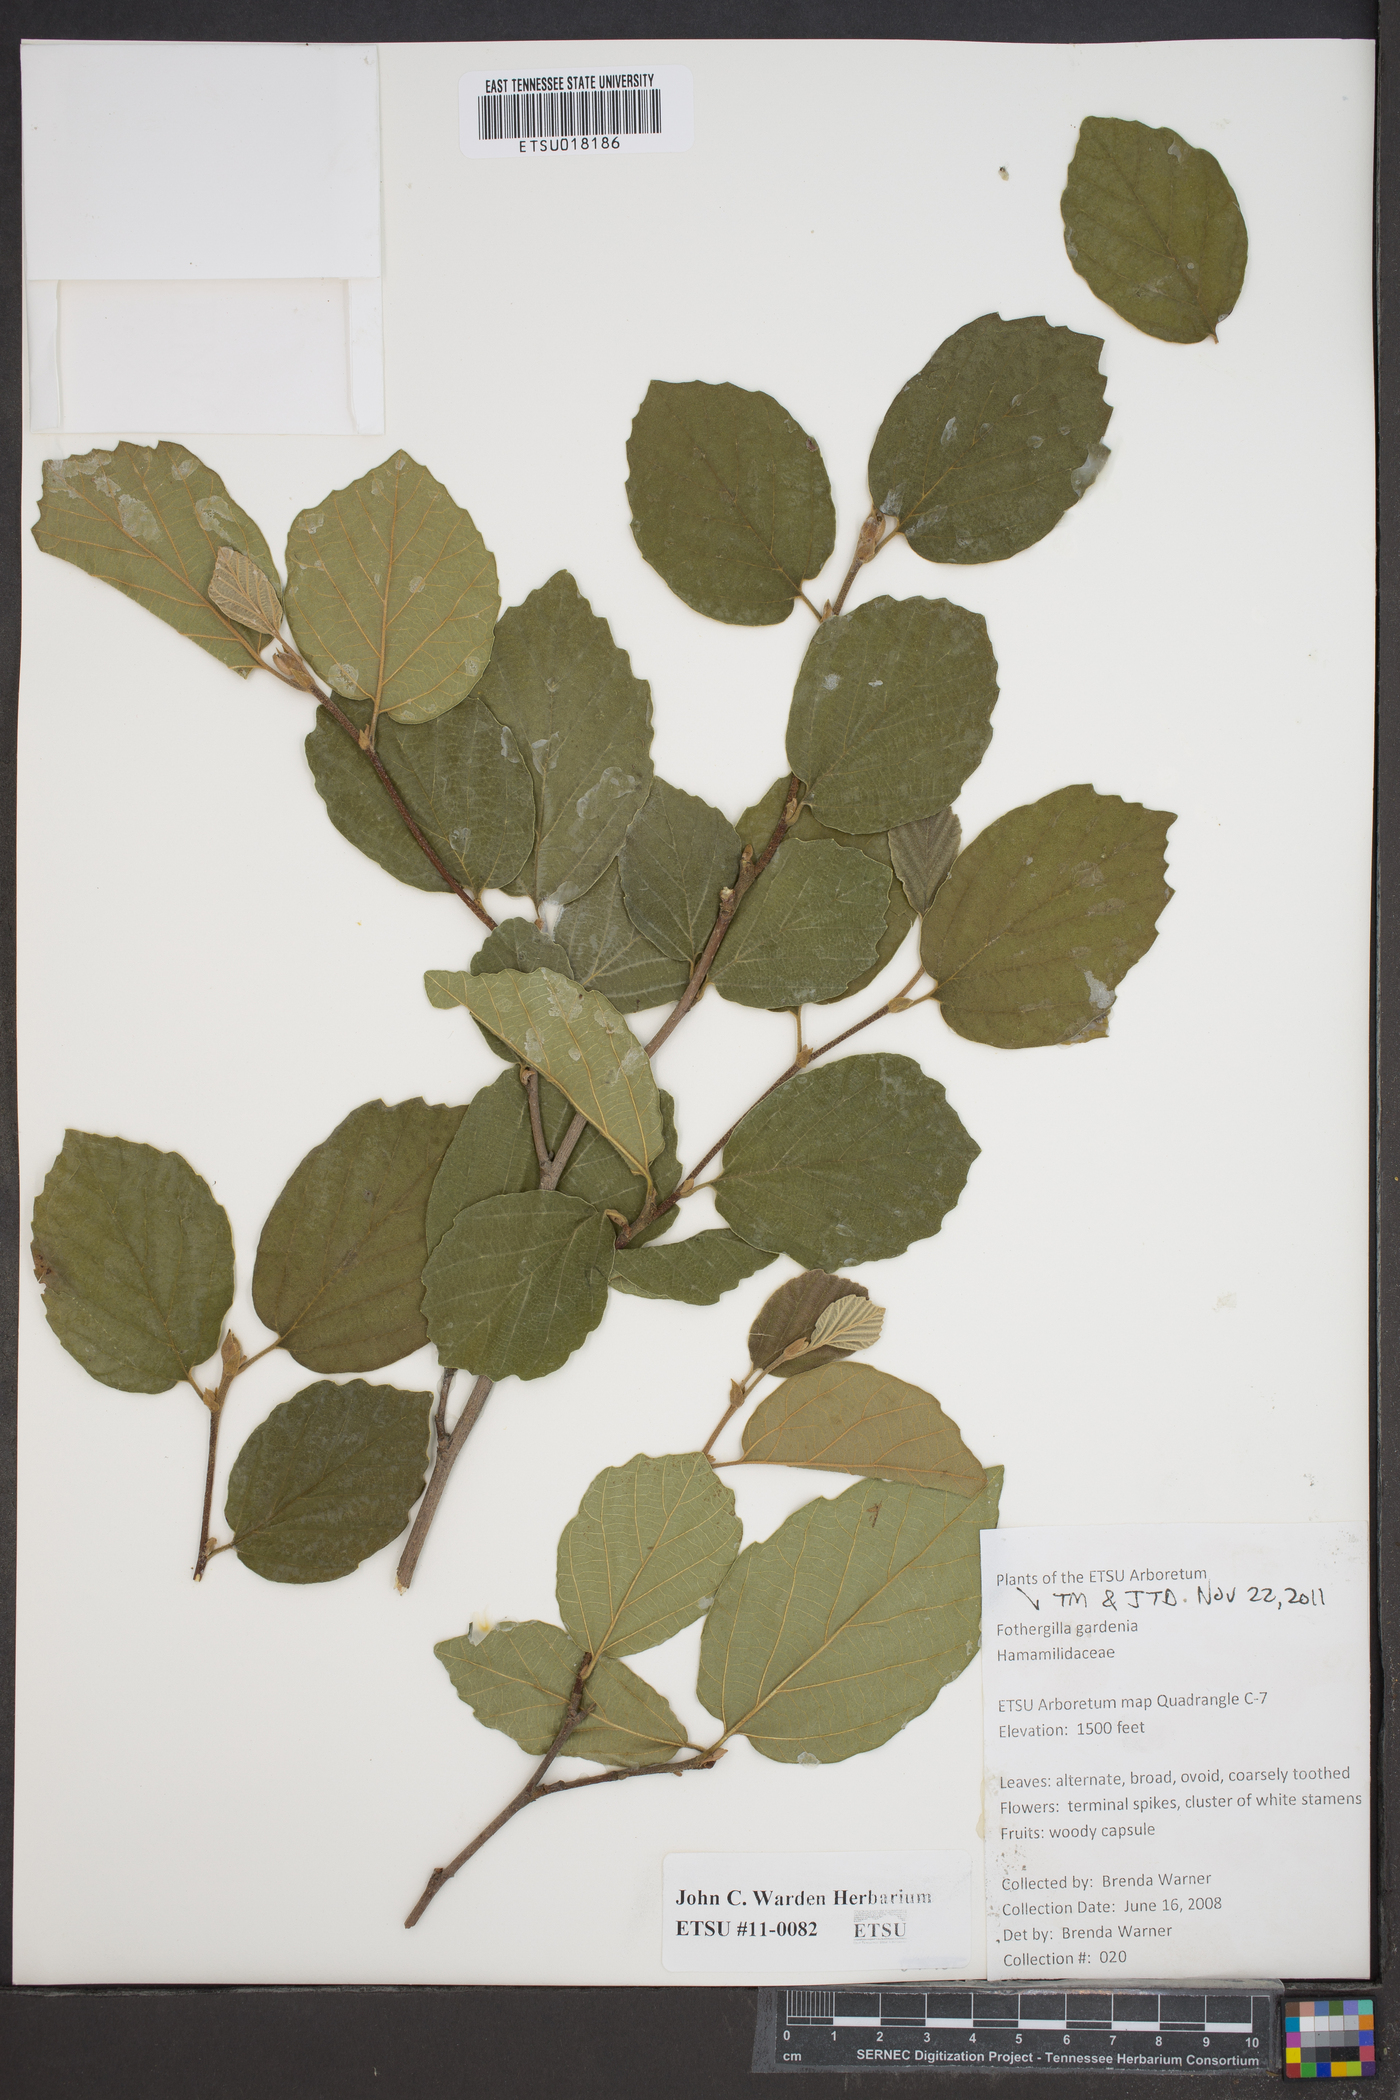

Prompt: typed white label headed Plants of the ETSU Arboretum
[{"left": 982, "top": 1525, "right": 1371, "bottom": 1982}]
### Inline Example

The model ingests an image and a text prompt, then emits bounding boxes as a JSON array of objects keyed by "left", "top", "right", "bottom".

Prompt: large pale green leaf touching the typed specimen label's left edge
[{"left": 697, "top": 1469, "right": 1001, "bottom": 1764}]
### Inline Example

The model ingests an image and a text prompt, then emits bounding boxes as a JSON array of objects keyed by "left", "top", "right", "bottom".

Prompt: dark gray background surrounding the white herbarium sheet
[{"left": 0, "top": 0, "right": 1376, "bottom": 2100}]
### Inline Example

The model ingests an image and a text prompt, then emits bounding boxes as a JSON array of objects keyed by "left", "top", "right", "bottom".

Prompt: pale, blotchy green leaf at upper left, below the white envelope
[{"left": 34, "top": 443, "right": 277, "bottom": 678}]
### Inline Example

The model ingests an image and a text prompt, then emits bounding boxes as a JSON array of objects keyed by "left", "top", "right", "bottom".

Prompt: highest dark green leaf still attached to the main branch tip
[{"left": 871, "top": 313, "right": 1112, "bottom": 567}]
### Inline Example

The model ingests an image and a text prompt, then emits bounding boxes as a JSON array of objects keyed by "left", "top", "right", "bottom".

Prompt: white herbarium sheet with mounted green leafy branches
[{"left": 15, "top": 42, "right": 1373, "bottom": 1985}]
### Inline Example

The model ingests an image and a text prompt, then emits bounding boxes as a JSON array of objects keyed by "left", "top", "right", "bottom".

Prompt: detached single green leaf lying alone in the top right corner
[{"left": 1060, "top": 118, "right": 1249, "bottom": 342}]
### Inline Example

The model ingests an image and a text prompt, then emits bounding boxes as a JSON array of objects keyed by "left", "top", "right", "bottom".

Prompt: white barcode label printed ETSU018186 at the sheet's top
[{"left": 460, "top": 55, "right": 693, "bottom": 160}]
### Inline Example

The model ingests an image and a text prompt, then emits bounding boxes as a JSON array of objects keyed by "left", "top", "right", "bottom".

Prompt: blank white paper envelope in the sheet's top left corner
[{"left": 21, "top": 42, "right": 384, "bottom": 435}]
